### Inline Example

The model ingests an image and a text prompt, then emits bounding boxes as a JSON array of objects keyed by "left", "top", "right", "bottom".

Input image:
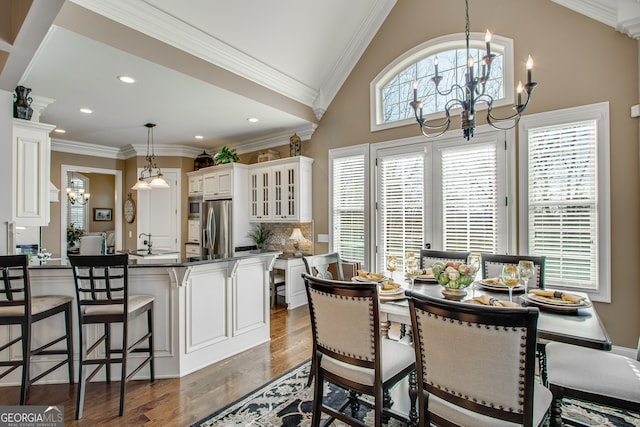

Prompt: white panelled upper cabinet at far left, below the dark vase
[{"left": 11, "top": 119, "right": 55, "bottom": 227}]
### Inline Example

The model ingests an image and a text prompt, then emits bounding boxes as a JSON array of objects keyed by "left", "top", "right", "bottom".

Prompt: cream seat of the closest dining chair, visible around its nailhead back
[{"left": 428, "top": 383, "right": 553, "bottom": 427}]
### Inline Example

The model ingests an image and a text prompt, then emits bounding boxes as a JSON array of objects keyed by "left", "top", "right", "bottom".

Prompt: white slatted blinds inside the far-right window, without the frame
[{"left": 527, "top": 120, "right": 599, "bottom": 290}]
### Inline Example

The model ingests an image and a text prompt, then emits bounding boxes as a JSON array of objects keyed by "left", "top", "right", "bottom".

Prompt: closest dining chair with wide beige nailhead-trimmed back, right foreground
[{"left": 409, "top": 291, "right": 552, "bottom": 427}]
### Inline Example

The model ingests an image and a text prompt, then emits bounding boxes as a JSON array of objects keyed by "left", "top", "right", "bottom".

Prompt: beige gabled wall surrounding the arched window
[{"left": 302, "top": 0, "right": 640, "bottom": 348}]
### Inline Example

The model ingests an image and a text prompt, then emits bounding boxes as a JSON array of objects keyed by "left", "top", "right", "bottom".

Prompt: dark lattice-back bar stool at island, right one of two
[{"left": 69, "top": 254, "right": 154, "bottom": 419}]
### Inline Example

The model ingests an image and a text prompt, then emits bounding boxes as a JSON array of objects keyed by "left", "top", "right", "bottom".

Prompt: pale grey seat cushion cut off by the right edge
[{"left": 546, "top": 342, "right": 640, "bottom": 404}]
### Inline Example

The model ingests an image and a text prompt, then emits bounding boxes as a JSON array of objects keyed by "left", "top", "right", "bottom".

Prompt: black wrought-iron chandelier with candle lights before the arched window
[{"left": 410, "top": 0, "right": 537, "bottom": 141}]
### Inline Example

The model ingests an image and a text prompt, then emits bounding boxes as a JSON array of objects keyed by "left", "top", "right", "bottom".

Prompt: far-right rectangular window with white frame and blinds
[{"left": 520, "top": 103, "right": 610, "bottom": 301}]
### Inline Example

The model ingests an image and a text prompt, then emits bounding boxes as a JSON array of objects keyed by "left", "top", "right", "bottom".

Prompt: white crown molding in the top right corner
[{"left": 552, "top": 0, "right": 640, "bottom": 40}]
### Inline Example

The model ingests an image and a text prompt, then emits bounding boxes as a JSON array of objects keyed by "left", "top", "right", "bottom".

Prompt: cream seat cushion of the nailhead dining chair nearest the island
[{"left": 321, "top": 339, "right": 416, "bottom": 385}]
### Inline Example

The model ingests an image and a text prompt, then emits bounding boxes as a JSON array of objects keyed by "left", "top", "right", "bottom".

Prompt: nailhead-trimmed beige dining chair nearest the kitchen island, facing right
[{"left": 303, "top": 274, "right": 415, "bottom": 427}]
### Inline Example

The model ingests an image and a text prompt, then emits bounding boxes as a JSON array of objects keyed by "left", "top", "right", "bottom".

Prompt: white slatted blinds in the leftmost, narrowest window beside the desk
[{"left": 331, "top": 154, "right": 365, "bottom": 263}]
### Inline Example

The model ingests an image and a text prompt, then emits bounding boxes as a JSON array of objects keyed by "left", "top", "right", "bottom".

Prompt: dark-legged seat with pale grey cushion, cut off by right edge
[{"left": 546, "top": 339, "right": 640, "bottom": 426}]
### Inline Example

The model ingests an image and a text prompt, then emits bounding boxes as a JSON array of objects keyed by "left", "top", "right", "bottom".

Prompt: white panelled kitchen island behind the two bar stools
[{"left": 0, "top": 252, "right": 279, "bottom": 385}]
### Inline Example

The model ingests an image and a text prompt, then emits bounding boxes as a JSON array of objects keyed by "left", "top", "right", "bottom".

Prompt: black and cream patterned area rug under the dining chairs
[{"left": 192, "top": 361, "right": 640, "bottom": 427}]
